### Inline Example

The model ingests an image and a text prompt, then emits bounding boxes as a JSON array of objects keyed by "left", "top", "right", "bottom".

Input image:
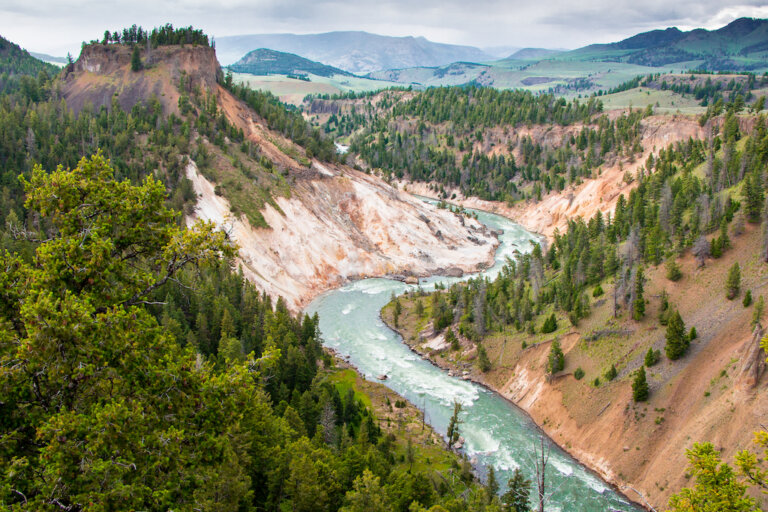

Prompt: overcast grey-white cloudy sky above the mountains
[{"left": 0, "top": 0, "right": 768, "bottom": 56}]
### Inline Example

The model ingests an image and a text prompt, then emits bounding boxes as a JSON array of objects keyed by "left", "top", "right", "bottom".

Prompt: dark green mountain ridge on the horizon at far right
[{"left": 563, "top": 18, "right": 768, "bottom": 71}]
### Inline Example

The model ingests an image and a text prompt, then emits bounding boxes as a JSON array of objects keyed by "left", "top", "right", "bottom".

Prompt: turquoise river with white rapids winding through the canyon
[{"left": 306, "top": 202, "right": 642, "bottom": 512}]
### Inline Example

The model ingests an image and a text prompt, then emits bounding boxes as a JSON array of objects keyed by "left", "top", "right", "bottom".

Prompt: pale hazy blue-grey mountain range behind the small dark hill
[{"left": 216, "top": 32, "right": 494, "bottom": 73}]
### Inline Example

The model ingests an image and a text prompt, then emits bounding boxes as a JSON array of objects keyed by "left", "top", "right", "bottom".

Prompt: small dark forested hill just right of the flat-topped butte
[{"left": 229, "top": 48, "right": 352, "bottom": 77}]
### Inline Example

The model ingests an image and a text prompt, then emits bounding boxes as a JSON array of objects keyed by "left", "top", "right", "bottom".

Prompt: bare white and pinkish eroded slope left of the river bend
[{"left": 187, "top": 162, "right": 498, "bottom": 311}]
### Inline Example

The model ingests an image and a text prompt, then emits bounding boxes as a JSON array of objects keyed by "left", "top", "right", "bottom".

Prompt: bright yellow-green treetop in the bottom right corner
[{"left": 669, "top": 443, "right": 759, "bottom": 512}]
